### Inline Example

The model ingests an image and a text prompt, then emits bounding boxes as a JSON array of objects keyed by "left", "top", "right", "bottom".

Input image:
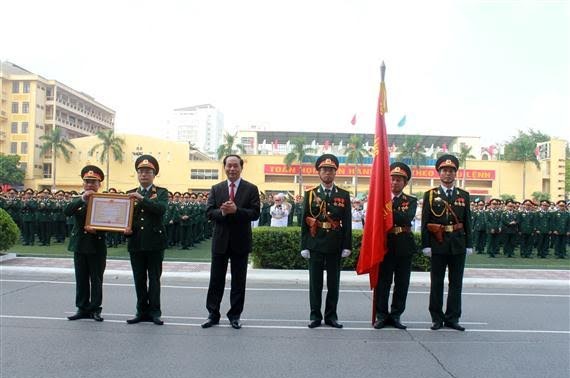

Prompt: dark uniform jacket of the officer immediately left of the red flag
[{"left": 301, "top": 185, "right": 352, "bottom": 254}]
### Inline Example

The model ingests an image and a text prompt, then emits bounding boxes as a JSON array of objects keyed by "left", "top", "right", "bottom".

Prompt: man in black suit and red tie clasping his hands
[{"left": 202, "top": 155, "right": 260, "bottom": 329}]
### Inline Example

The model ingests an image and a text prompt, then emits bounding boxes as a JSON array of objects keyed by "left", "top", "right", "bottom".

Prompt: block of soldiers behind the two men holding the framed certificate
[{"left": 0, "top": 188, "right": 212, "bottom": 249}]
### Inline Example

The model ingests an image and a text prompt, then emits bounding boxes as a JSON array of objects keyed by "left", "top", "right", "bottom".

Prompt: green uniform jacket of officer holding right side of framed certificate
[{"left": 127, "top": 185, "right": 168, "bottom": 252}]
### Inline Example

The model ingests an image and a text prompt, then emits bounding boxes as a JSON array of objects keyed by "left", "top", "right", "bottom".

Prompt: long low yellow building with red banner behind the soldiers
[{"left": 33, "top": 135, "right": 566, "bottom": 200}]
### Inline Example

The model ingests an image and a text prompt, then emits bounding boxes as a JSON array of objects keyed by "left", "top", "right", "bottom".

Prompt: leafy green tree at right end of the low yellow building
[{"left": 504, "top": 129, "right": 550, "bottom": 199}]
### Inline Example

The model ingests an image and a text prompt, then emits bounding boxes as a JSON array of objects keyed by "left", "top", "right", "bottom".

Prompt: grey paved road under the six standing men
[{"left": 0, "top": 268, "right": 570, "bottom": 378}]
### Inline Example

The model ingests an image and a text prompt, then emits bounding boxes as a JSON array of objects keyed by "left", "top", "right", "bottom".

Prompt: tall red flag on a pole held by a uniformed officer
[{"left": 356, "top": 64, "right": 393, "bottom": 289}]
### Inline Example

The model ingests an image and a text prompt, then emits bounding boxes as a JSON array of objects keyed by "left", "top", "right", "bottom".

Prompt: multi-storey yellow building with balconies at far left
[{"left": 0, "top": 62, "right": 115, "bottom": 186}]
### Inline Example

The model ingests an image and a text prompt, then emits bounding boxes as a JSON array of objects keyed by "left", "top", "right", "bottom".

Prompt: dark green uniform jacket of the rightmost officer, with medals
[{"left": 422, "top": 187, "right": 473, "bottom": 255}]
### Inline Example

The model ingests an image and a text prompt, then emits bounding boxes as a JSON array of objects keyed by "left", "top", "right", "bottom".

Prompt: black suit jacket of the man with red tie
[{"left": 206, "top": 179, "right": 261, "bottom": 255}]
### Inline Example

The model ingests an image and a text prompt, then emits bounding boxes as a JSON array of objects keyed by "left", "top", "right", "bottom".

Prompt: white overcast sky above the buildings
[{"left": 0, "top": 0, "right": 570, "bottom": 144}]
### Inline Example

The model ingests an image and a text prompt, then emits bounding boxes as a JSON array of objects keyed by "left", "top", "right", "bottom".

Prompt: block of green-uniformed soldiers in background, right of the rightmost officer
[{"left": 471, "top": 198, "right": 570, "bottom": 258}]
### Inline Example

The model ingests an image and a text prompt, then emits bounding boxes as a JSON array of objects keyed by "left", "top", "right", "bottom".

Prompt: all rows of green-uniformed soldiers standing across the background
[{"left": 0, "top": 188, "right": 570, "bottom": 258}]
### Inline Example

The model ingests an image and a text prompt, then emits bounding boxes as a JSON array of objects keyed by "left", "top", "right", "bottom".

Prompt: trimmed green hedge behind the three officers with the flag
[{"left": 251, "top": 227, "right": 430, "bottom": 272}]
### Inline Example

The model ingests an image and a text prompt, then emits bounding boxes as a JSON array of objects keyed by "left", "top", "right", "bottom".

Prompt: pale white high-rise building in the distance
[{"left": 169, "top": 104, "right": 224, "bottom": 157}]
